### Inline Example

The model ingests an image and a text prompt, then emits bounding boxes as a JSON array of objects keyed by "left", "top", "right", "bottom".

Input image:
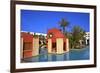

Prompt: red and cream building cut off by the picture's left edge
[{"left": 21, "top": 32, "right": 39, "bottom": 58}]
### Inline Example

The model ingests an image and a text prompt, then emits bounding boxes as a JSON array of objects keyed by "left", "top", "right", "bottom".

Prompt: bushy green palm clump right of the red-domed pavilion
[{"left": 70, "top": 26, "right": 85, "bottom": 48}]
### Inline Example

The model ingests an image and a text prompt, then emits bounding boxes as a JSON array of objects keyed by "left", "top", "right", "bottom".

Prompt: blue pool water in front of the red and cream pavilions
[{"left": 22, "top": 47, "right": 89, "bottom": 62}]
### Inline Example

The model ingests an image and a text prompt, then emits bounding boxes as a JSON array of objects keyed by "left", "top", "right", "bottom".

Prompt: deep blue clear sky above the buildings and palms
[{"left": 21, "top": 10, "right": 90, "bottom": 33}]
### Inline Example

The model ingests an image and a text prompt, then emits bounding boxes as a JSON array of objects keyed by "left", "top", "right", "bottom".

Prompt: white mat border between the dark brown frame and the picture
[{"left": 16, "top": 5, "right": 94, "bottom": 69}]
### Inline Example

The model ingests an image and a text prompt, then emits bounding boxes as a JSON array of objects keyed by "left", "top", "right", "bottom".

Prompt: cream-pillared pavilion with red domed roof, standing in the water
[{"left": 47, "top": 28, "right": 69, "bottom": 54}]
